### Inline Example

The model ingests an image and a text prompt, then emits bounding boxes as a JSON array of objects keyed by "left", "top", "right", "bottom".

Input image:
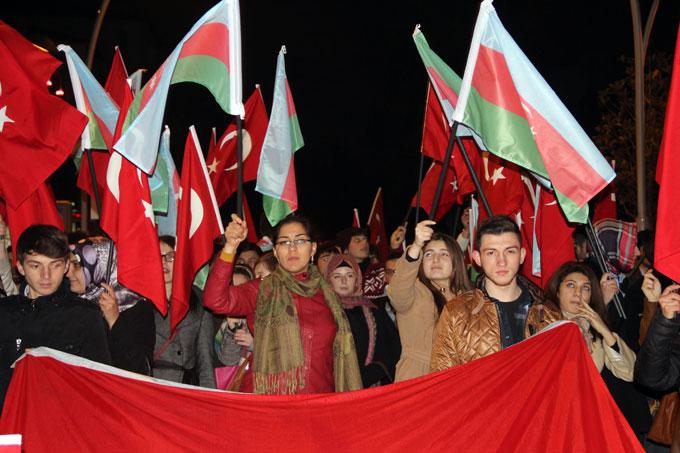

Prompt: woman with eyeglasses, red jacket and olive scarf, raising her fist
[{"left": 204, "top": 214, "right": 361, "bottom": 395}]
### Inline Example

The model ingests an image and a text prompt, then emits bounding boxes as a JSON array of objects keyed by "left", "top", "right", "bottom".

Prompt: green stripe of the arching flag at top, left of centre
[{"left": 170, "top": 55, "right": 229, "bottom": 112}]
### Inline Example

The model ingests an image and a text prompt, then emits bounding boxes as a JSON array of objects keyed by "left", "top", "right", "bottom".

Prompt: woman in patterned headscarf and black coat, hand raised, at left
[{"left": 66, "top": 241, "right": 155, "bottom": 376}]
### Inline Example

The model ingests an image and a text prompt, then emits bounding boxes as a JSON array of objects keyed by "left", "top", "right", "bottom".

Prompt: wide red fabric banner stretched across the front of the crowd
[{"left": 0, "top": 323, "right": 643, "bottom": 453}]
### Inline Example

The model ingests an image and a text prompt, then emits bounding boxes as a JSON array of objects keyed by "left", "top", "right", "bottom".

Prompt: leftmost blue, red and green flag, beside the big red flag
[{"left": 57, "top": 44, "right": 120, "bottom": 155}]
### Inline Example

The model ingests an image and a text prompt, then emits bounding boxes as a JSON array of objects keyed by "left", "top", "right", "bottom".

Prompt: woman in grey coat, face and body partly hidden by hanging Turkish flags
[{"left": 153, "top": 236, "right": 215, "bottom": 388}]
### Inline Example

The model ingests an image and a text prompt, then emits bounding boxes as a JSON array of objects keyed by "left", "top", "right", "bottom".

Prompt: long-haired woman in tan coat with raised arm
[{"left": 387, "top": 220, "right": 471, "bottom": 382}]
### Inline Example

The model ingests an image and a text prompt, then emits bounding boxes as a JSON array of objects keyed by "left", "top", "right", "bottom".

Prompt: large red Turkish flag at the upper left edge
[{"left": 0, "top": 21, "right": 87, "bottom": 209}]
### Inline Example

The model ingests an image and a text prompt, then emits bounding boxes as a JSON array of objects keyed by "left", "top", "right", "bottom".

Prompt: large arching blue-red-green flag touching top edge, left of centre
[{"left": 114, "top": 0, "right": 244, "bottom": 174}]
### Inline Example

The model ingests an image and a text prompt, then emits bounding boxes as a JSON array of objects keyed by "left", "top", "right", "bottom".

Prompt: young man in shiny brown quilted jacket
[{"left": 430, "top": 216, "right": 561, "bottom": 371}]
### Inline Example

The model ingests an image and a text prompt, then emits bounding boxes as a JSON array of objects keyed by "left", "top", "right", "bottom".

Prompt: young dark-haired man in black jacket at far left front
[{"left": 0, "top": 225, "right": 111, "bottom": 407}]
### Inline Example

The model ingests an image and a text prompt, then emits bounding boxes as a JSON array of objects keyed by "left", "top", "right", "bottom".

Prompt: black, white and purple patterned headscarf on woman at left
[{"left": 72, "top": 241, "right": 142, "bottom": 313}]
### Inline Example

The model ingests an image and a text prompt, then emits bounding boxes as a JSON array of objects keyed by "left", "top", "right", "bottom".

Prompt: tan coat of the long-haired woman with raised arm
[{"left": 387, "top": 253, "right": 439, "bottom": 382}]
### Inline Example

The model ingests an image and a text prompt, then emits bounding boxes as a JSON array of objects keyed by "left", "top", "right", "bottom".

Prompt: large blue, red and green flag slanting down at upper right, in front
[{"left": 453, "top": 0, "right": 616, "bottom": 223}]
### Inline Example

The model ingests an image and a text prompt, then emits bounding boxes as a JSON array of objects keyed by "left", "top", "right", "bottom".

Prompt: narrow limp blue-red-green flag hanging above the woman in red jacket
[{"left": 255, "top": 46, "right": 304, "bottom": 225}]
